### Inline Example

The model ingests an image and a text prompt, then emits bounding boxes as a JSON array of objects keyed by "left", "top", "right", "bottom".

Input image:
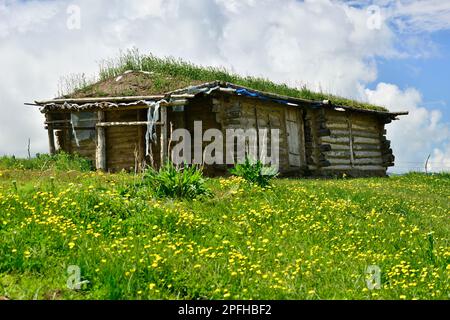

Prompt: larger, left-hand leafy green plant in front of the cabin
[{"left": 144, "top": 162, "right": 211, "bottom": 199}]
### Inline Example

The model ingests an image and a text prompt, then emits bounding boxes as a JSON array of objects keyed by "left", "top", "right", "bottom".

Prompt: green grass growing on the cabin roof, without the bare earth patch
[{"left": 67, "top": 50, "right": 387, "bottom": 111}]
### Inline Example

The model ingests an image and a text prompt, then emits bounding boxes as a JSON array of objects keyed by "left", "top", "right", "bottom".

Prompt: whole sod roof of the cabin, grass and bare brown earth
[{"left": 66, "top": 50, "right": 387, "bottom": 111}]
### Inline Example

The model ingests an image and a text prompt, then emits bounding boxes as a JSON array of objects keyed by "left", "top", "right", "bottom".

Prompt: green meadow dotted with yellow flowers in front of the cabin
[{"left": 0, "top": 165, "right": 450, "bottom": 299}]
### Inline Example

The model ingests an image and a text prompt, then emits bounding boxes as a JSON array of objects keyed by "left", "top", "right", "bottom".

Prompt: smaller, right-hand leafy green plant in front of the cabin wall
[{"left": 230, "top": 158, "right": 278, "bottom": 188}]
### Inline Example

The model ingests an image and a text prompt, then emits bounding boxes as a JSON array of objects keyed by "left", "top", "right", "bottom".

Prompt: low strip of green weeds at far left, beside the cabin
[{"left": 0, "top": 152, "right": 92, "bottom": 171}]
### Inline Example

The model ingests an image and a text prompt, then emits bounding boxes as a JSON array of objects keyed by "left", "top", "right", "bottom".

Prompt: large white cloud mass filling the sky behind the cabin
[{"left": 0, "top": 0, "right": 448, "bottom": 172}]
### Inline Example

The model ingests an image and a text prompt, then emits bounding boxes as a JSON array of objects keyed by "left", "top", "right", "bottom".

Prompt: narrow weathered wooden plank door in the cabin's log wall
[{"left": 286, "top": 108, "right": 302, "bottom": 167}]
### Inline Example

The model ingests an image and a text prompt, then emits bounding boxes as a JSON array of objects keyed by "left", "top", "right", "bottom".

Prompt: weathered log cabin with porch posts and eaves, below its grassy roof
[{"left": 31, "top": 72, "right": 407, "bottom": 177}]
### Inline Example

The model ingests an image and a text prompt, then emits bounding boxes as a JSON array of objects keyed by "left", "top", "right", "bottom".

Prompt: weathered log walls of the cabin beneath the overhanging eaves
[{"left": 46, "top": 93, "right": 395, "bottom": 177}]
